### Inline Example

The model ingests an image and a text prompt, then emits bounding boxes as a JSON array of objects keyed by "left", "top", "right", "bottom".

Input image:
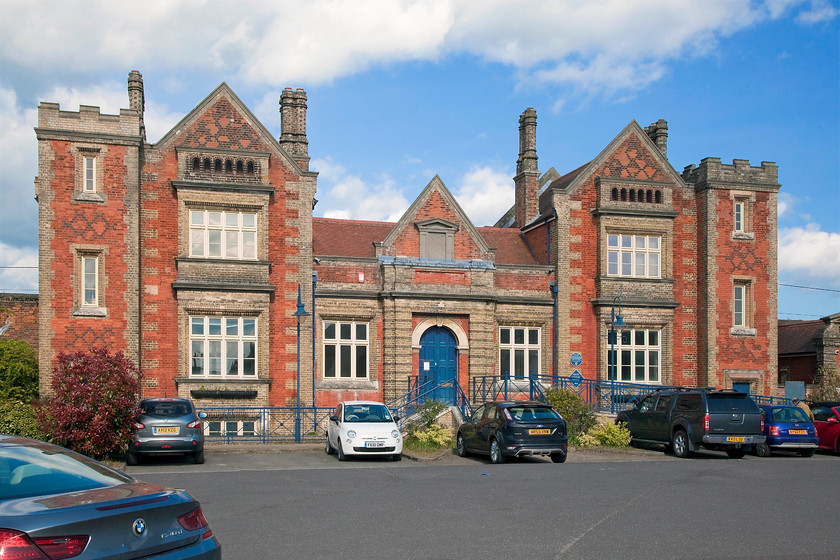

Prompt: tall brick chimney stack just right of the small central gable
[{"left": 513, "top": 107, "right": 540, "bottom": 228}]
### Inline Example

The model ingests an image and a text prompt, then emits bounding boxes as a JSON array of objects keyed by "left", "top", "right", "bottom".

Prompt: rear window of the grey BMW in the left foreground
[{"left": 0, "top": 445, "right": 134, "bottom": 501}]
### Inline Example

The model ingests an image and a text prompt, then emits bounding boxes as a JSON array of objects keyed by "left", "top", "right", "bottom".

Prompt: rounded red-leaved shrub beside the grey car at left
[{"left": 41, "top": 348, "right": 142, "bottom": 458}]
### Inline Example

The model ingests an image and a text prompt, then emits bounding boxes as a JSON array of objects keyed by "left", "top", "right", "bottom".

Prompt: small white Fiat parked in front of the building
[{"left": 326, "top": 401, "right": 402, "bottom": 461}]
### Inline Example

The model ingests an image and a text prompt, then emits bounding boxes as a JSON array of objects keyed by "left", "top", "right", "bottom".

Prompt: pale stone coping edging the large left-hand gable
[{"left": 153, "top": 82, "right": 312, "bottom": 175}]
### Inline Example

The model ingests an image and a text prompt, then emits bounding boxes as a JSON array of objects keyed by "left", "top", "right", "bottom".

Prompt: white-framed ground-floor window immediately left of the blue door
[{"left": 323, "top": 321, "right": 369, "bottom": 379}]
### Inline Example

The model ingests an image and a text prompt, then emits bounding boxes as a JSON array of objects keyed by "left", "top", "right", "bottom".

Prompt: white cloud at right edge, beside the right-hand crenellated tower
[{"left": 779, "top": 224, "right": 840, "bottom": 288}]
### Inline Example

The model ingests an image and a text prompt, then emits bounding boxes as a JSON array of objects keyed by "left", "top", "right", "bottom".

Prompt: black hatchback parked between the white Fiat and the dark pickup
[{"left": 456, "top": 401, "right": 568, "bottom": 463}]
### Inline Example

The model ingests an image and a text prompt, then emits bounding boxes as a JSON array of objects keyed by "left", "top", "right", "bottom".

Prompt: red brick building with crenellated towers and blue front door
[{"left": 36, "top": 72, "right": 779, "bottom": 418}]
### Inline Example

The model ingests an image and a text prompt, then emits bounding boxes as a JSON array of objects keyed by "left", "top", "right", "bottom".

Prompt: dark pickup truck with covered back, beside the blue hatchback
[{"left": 616, "top": 388, "right": 766, "bottom": 459}]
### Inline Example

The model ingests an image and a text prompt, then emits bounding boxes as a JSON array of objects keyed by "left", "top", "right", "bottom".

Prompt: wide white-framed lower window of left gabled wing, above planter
[{"left": 190, "top": 316, "right": 257, "bottom": 378}]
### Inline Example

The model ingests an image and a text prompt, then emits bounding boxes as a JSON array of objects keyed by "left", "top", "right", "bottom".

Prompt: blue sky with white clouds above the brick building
[{"left": 0, "top": 0, "right": 840, "bottom": 319}]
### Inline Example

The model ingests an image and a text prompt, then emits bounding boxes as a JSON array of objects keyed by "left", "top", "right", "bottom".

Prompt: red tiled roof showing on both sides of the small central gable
[{"left": 312, "top": 218, "right": 544, "bottom": 266}]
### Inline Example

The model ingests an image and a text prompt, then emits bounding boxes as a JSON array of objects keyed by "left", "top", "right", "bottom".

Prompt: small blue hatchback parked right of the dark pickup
[{"left": 755, "top": 404, "right": 819, "bottom": 457}]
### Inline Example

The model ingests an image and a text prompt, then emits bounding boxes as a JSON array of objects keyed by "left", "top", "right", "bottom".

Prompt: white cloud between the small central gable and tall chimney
[{"left": 452, "top": 166, "right": 514, "bottom": 226}]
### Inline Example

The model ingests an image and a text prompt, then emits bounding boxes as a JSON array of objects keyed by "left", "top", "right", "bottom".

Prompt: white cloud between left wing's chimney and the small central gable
[{"left": 310, "top": 158, "right": 409, "bottom": 222}]
